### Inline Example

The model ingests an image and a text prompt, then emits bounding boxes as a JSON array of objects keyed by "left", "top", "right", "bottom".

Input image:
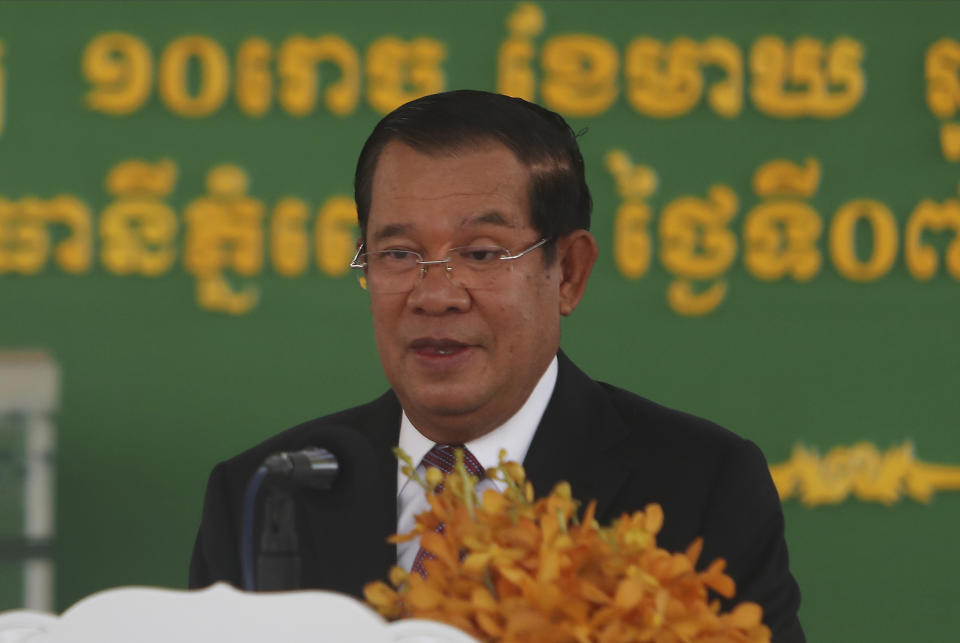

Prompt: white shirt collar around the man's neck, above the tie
[{"left": 397, "top": 357, "right": 558, "bottom": 495}]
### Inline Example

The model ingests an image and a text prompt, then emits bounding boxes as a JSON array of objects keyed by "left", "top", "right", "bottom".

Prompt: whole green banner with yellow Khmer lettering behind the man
[{"left": 0, "top": 1, "right": 960, "bottom": 641}]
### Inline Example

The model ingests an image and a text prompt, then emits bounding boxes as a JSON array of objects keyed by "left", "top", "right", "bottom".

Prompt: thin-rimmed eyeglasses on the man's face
[{"left": 350, "top": 237, "right": 547, "bottom": 294}]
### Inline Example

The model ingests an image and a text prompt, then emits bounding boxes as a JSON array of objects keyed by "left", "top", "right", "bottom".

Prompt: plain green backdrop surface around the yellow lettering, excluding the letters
[{"left": 0, "top": 2, "right": 960, "bottom": 641}]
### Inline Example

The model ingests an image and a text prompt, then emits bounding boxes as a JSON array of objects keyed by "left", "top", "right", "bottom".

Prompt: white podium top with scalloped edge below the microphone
[{"left": 0, "top": 583, "right": 475, "bottom": 643}]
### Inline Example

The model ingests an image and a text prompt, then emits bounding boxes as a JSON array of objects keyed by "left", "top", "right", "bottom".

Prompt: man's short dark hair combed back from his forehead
[{"left": 353, "top": 89, "right": 592, "bottom": 260}]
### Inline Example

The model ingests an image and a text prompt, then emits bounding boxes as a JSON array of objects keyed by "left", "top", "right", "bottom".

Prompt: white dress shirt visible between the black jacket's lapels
[{"left": 397, "top": 357, "right": 557, "bottom": 571}]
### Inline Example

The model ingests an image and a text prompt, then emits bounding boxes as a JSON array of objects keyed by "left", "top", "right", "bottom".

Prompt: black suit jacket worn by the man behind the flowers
[{"left": 190, "top": 352, "right": 804, "bottom": 642}]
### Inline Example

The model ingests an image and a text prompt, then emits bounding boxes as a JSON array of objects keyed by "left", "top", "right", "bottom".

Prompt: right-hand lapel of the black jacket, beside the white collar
[{"left": 523, "top": 351, "right": 629, "bottom": 517}]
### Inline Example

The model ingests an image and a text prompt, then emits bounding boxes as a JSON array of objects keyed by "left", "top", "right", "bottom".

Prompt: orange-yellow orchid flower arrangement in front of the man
[{"left": 364, "top": 451, "right": 770, "bottom": 643}]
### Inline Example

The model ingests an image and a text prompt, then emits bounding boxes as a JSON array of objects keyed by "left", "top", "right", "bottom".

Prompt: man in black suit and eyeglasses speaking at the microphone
[{"left": 190, "top": 91, "right": 803, "bottom": 641}]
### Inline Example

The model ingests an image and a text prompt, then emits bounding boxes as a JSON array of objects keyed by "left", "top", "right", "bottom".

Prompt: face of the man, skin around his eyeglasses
[{"left": 366, "top": 141, "right": 575, "bottom": 442}]
